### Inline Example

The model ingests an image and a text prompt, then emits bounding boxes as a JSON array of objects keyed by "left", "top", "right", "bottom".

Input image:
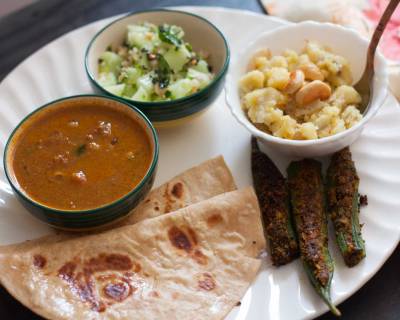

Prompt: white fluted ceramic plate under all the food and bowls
[{"left": 0, "top": 7, "right": 400, "bottom": 320}]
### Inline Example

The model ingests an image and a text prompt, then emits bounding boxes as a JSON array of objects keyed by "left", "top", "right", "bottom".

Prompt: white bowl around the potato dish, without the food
[{"left": 225, "top": 21, "right": 388, "bottom": 157}]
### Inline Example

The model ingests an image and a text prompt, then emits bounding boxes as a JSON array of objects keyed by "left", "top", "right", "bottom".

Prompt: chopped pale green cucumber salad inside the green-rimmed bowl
[{"left": 97, "top": 22, "right": 213, "bottom": 101}]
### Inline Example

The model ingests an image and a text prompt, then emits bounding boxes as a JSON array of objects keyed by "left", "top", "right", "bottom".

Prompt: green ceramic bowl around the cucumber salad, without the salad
[{"left": 85, "top": 9, "right": 230, "bottom": 126}]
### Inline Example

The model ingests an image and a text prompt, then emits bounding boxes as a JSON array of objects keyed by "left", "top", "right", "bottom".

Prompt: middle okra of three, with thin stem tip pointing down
[{"left": 288, "top": 159, "right": 340, "bottom": 315}]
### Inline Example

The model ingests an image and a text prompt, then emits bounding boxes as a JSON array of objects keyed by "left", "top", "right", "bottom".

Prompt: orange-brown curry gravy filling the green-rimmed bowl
[{"left": 12, "top": 102, "right": 152, "bottom": 210}]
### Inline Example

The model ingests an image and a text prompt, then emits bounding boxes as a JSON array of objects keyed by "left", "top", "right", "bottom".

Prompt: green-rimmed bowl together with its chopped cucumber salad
[{"left": 85, "top": 9, "right": 230, "bottom": 126}]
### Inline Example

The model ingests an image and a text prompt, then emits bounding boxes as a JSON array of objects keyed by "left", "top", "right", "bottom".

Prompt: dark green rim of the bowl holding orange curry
[{"left": 3, "top": 94, "right": 159, "bottom": 214}]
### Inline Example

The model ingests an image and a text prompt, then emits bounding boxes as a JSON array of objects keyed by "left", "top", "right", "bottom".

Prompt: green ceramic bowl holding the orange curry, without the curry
[{"left": 4, "top": 95, "right": 159, "bottom": 231}]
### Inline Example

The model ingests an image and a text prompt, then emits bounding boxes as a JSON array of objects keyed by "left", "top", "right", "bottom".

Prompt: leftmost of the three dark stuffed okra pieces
[{"left": 251, "top": 137, "right": 298, "bottom": 266}]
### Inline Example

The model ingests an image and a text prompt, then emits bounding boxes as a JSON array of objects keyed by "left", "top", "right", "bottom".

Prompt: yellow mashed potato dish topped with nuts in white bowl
[{"left": 239, "top": 41, "right": 362, "bottom": 140}]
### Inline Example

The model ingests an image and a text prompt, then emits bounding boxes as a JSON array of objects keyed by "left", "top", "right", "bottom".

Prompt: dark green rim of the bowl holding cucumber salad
[{"left": 84, "top": 8, "right": 230, "bottom": 108}]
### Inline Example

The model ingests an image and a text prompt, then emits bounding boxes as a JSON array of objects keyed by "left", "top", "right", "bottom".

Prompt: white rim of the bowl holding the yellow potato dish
[{"left": 225, "top": 21, "right": 389, "bottom": 147}]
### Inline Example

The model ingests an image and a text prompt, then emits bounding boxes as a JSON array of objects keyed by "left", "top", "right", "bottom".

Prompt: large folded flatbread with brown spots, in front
[{"left": 0, "top": 188, "right": 265, "bottom": 320}]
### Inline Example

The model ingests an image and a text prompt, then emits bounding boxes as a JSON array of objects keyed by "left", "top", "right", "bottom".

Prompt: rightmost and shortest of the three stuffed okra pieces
[{"left": 327, "top": 148, "right": 365, "bottom": 267}]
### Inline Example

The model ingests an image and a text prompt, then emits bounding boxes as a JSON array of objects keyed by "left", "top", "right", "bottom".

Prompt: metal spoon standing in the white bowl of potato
[{"left": 354, "top": 0, "right": 400, "bottom": 115}]
